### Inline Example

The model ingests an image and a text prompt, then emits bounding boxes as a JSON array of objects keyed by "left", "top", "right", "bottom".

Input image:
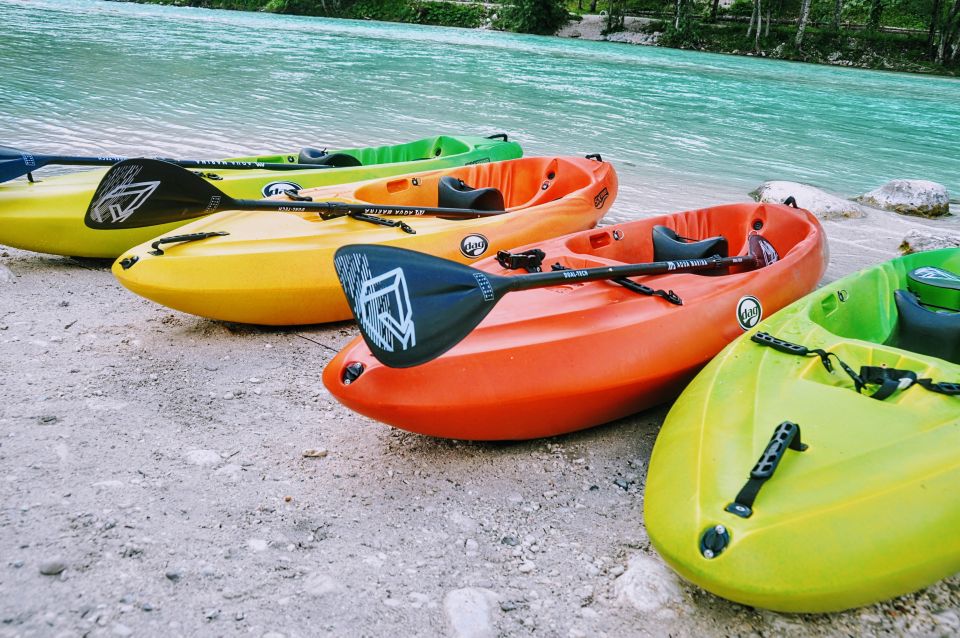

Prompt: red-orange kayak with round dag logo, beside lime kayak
[{"left": 323, "top": 203, "right": 827, "bottom": 440}]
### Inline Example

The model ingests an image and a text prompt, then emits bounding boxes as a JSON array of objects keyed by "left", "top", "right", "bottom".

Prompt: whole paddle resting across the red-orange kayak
[{"left": 334, "top": 235, "right": 779, "bottom": 368}]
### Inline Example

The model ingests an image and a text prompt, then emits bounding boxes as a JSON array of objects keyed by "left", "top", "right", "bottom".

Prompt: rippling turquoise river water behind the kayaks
[{"left": 0, "top": 0, "right": 960, "bottom": 219}]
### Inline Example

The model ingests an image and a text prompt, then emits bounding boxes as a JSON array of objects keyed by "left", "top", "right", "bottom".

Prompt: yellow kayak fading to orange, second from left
[{"left": 112, "top": 157, "right": 617, "bottom": 325}]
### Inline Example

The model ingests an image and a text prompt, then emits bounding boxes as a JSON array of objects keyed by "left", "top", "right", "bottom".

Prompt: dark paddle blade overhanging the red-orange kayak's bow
[{"left": 333, "top": 244, "right": 510, "bottom": 368}]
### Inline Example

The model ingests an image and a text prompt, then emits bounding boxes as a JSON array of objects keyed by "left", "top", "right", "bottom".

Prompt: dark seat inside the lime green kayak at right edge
[{"left": 893, "top": 290, "right": 960, "bottom": 363}]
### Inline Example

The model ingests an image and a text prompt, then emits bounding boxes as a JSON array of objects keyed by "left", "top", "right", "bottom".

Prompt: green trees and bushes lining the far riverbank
[{"left": 125, "top": 0, "right": 960, "bottom": 74}]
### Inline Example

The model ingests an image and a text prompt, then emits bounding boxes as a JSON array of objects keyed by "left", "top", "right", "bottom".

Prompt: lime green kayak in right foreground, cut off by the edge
[{"left": 644, "top": 249, "right": 960, "bottom": 612}]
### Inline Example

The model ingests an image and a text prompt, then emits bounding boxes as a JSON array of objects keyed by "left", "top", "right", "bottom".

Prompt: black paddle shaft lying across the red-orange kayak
[{"left": 507, "top": 255, "right": 757, "bottom": 292}]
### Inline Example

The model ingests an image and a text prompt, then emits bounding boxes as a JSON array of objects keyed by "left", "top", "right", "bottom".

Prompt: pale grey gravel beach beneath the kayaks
[{"left": 0, "top": 198, "right": 960, "bottom": 638}]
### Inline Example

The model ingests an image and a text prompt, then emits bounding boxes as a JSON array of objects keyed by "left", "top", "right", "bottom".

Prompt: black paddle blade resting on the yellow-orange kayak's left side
[{"left": 83, "top": 158, "right": 233, "bottom": 230}]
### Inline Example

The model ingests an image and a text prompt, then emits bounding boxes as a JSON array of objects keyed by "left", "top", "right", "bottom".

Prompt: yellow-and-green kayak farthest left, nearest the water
[{"left": 0, "top": 135, "right": 522, "bottom": 258}]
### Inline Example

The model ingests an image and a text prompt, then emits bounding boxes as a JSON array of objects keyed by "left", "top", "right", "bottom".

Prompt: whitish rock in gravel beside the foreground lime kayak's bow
[{"left": 614, "top": 554, "right": 686, "bottom": 617}]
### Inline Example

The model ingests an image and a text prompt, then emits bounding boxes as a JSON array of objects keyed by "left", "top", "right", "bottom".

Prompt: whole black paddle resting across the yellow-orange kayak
[{"left": 83, "top": 159, "right": 504, "bottom": 232}]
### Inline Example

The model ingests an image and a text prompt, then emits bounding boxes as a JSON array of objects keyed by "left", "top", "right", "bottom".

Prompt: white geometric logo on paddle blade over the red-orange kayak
[{"left": 334, "top": 254, "right": 417, "bottom": 352}]
